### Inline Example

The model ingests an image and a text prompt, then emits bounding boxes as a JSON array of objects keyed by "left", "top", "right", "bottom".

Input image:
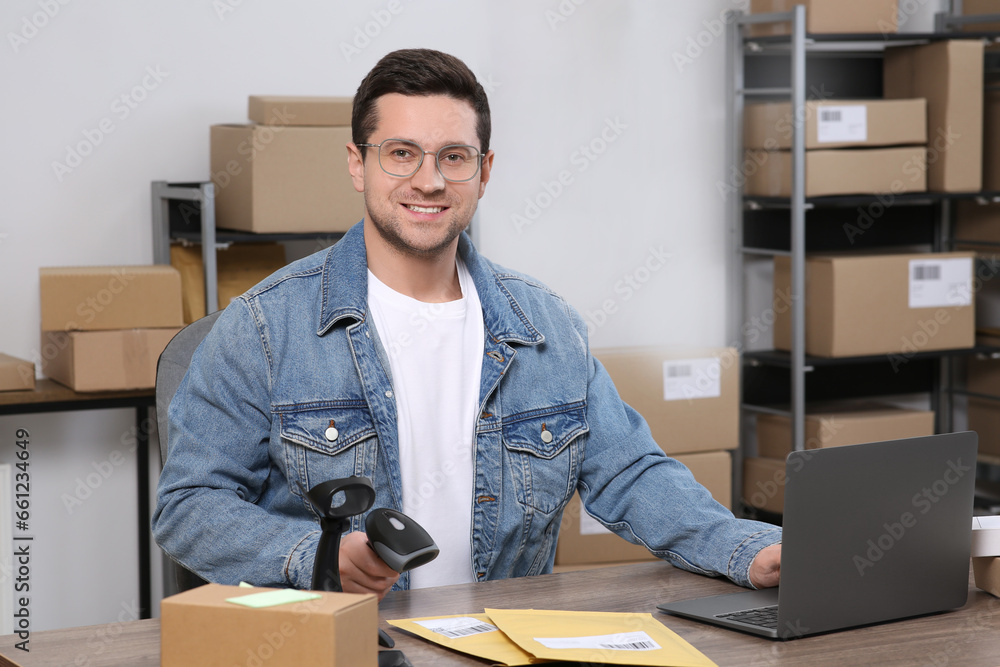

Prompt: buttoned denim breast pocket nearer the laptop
[{"left": 501, "top": 406, "right": 589, "bottom": 513}]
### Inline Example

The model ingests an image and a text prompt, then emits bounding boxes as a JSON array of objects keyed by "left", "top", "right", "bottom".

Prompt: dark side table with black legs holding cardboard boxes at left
[{"left": 0, "top": 380, "right": 156, "bottom": 618}]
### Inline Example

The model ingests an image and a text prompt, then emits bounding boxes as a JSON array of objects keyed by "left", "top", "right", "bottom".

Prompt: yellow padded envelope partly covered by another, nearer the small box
[{"left": 388, "top": 614, "right": 550, "bottom": 667}]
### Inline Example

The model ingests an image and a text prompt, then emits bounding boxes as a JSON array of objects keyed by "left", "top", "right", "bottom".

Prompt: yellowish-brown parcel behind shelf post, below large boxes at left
[{"left": 170, "top": 243, "right": 285, "bottom": 324}]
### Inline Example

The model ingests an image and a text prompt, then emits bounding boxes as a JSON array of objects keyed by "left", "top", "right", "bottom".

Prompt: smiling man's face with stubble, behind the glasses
[{"left": 348, "top": 93, "right": 493, "bottom": 257}]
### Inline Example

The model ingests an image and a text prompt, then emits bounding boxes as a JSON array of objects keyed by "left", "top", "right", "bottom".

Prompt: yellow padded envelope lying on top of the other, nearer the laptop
[{"left": 486, "top": 609, "right": 715, "bottom": 667}]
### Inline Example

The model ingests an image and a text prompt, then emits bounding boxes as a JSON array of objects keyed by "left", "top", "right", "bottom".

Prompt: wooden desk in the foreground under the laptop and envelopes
[{"left": 0, "top": 562, "right": 1000, "bottom": 667}]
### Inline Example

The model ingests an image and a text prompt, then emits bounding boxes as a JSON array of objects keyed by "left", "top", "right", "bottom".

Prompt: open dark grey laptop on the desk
[{"left": 658, "top": 431, "right": 978, "bottom": 639}]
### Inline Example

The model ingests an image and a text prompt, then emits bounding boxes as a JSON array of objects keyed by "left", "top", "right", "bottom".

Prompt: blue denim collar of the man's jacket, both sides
[{"left": 316, "top": 221, "right": 545, "bottom": 345}]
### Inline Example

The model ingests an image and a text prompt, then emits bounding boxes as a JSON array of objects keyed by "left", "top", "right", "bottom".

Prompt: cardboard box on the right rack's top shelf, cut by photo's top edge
[{"left": 750, "top": 0, "right": 899, "bottom": 35}]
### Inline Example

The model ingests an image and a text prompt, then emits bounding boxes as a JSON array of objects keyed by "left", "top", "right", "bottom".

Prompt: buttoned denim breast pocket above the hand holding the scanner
[{"left": 278, "top": 401, "right": 377, "bottom": 506}]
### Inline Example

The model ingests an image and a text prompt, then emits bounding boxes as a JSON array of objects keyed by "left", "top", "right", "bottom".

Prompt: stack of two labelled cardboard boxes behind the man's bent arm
[{"left": 556, "top": 347, "right": 739, "bottom": 565}]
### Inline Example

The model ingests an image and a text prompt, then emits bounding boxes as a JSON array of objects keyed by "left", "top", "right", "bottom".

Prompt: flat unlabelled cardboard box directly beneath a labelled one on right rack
[{"left": 743, "top": 146, "right": 927, "bottom": 197}]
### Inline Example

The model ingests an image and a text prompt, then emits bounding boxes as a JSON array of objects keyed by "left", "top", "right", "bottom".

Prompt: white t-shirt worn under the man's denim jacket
[{"left": 368, "top": 260, "right": 484, "bottom": 588}]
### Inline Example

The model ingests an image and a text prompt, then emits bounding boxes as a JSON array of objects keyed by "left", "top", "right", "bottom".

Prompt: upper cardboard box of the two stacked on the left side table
[{"left": 38, "top": 265, "right": 184, "bottom": 331}]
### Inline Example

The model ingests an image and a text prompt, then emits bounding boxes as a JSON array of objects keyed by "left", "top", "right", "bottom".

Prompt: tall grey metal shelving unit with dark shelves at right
[{"left": 726, "top": 3, "right": 1000, "bottom": 520}]
